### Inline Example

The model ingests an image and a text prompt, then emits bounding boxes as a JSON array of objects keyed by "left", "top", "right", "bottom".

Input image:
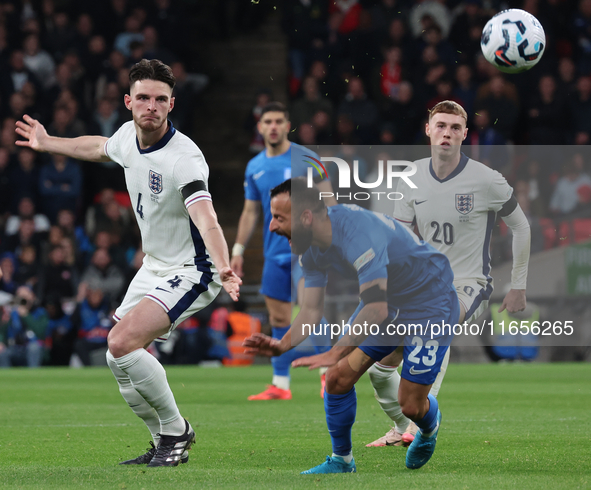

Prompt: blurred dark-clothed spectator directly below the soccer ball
[{"left": 475, "top": 74, "right": 519, "bottom": 140}]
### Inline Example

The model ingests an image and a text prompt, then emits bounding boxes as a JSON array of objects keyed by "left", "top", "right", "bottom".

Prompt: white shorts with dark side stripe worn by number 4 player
[{"left": 113, "top": 266, "right": 222, "bottom": 342}]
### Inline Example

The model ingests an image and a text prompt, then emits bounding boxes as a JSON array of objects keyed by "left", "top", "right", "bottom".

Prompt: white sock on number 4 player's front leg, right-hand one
[{"left": 115, "top": 349, "right": 186, "bottom": 436}]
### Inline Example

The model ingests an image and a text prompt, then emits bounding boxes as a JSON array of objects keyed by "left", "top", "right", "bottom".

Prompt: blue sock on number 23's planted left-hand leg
[{"left": 324, "top": 387, "right": 357, "bottom": 456}]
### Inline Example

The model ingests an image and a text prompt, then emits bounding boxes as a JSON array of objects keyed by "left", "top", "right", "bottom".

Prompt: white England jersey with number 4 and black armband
[{"left": 105, "top": 121, "right": 215, "bottom": 274}]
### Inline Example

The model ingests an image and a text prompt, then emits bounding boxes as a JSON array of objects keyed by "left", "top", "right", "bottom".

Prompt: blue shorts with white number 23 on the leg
[{"left": 357, "top": 285, "right": 460, "bottom": 385}]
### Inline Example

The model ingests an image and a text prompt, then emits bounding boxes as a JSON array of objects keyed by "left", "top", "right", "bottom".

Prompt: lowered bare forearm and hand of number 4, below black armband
[{"left": 188, "top": 200, "right": 242, "bottom": 301}]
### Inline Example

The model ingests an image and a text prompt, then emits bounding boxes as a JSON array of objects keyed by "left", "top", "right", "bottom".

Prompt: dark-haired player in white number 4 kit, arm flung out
[{"left": 16, "top": 60, "right": 242, "bottom": 467}]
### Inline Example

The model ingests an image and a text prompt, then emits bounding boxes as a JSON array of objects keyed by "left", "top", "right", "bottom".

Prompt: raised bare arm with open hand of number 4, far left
[{"left": 15, "top": 114, "right": 109, "bottom": 162}]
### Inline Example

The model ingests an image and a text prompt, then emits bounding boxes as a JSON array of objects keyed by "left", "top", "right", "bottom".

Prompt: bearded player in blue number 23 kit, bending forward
[{"left": 244, "top": 179, "right": 460, "bottom": 474}]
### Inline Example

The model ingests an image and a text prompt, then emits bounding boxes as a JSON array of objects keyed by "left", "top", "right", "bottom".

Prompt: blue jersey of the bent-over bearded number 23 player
[{"left": 302, "top": 204, "right": 453, "bottom": 315}]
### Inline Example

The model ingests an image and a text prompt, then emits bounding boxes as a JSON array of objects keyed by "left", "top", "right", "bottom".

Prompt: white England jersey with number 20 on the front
[{"left": 394, "top": 154, "right": 513, "bottom": 288}]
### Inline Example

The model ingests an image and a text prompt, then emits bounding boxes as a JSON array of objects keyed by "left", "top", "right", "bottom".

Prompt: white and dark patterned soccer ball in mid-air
[{"left": 480, "top": 9, "right": 546, "bottom": 73}]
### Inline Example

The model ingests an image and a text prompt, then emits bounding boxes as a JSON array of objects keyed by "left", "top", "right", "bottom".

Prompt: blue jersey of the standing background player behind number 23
[{"left": 244, "top": 143, "right": 319, "bottom": 263}]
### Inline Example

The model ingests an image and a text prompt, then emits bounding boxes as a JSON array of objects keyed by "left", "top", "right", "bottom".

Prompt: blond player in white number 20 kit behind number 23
[{"left": 368, "top": 101, "right": 530, "bottom": 446}]
